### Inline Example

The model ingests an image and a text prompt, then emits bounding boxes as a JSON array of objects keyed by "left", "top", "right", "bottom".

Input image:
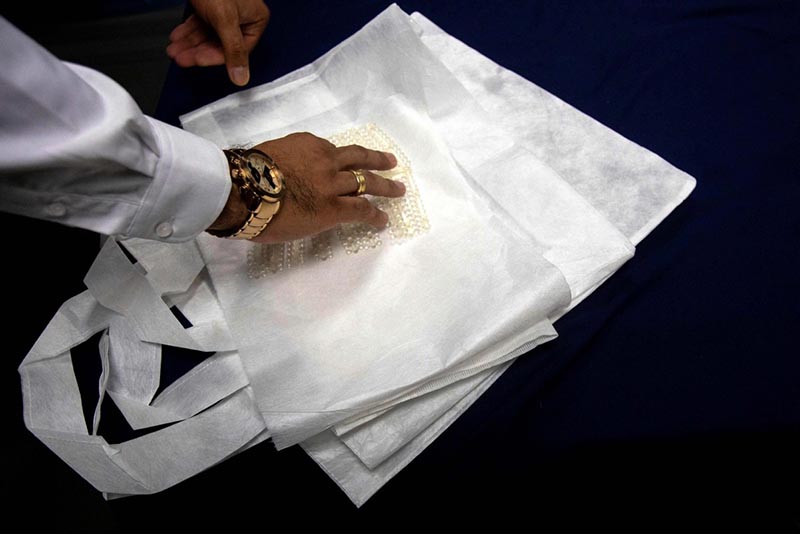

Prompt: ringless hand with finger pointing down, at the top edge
[{"left": 167, "top": 0, "right": 269, "bottom": 85}]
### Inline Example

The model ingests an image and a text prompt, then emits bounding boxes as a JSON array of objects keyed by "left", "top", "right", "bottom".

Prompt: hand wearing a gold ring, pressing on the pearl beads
[{"left": 211, "top": 133, "right": 406, "bottom": 243}]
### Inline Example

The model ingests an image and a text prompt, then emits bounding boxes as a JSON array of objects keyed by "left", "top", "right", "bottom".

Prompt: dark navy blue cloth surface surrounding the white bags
[{"left": 6, "top": 0, "right": 800, "bottom": 530}]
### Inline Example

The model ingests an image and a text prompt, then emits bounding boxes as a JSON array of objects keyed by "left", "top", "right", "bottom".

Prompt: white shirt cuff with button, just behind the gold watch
[{"left": 128, "top": 117, "right": 231, "bottom": 242}]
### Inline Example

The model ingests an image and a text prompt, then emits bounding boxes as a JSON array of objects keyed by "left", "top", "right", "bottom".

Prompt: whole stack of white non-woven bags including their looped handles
[{"left": 20, "top": 5, "right": 694, "bottom": 506}]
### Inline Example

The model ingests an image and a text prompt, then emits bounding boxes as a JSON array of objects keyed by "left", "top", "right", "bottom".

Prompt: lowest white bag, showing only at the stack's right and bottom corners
[{"left": 288, "top": 13, "right": 695, "bottom": 505}]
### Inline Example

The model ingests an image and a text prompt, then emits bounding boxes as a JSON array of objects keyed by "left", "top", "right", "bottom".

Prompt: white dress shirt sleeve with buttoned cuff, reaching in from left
[{"left": 0, "top": 17, "right": 231, "bottom": 242}]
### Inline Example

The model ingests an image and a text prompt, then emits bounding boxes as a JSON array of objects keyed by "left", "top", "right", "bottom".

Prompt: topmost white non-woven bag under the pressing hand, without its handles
[{"left": 182, "top": 6, "right": 633, "bottom": 456}]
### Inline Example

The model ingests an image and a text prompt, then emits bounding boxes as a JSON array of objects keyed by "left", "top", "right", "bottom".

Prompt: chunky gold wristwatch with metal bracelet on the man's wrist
[{"left": 206, "top": 148, "right": 285, "bottom": 239}]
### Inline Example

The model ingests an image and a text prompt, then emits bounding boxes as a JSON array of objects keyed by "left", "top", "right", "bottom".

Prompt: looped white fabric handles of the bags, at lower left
[{"left": 19, "top": 239, "right": 269, "bottom": 498}]
